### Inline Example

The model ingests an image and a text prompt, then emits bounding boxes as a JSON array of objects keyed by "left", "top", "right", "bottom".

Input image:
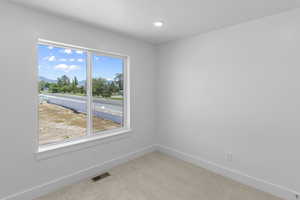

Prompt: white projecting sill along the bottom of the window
[{"left": 35, "top": 129, "right": 131, "bottom": 160}]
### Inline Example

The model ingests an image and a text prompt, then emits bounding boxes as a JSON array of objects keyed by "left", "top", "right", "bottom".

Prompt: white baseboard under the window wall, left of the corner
[{"left": 1, "top": 146, "right": 156, "bottom": 200}]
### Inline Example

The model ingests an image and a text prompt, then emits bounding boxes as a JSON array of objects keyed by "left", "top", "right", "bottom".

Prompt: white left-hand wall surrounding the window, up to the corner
[{"left": 0, "top": 1, "right": 156, "bottom": 199}]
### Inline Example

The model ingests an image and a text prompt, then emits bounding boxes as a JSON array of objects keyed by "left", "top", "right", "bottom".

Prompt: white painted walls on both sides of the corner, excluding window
[{"left": 0, "top": 1, "right": 300, "bottom": 199}]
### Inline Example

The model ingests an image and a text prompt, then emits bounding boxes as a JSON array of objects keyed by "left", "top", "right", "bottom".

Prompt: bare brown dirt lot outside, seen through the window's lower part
[{"left": 39, "top": 103, "right": 121, "bottom": 144}]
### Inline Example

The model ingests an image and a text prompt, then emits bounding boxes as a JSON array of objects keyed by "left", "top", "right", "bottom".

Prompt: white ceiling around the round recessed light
[{"left": 10, "top": 0, "right": 300, "bottom": 44}]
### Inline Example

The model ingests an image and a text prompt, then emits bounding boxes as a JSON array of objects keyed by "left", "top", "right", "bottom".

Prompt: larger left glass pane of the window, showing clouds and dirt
[{"left": 38, "top": 44, "right": 87, "bottom": 144}]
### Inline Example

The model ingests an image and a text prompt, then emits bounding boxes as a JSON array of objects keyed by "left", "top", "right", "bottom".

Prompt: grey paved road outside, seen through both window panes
[{"left": 40, "top": 94, "right": 123, "bottom": 116}]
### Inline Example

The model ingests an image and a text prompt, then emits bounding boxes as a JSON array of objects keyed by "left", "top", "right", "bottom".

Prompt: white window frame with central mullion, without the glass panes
[{"left": 36, "top": 39, "right": 131, "bottom": 158}]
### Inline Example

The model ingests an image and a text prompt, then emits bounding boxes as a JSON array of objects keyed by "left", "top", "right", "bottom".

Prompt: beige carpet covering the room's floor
[{"left": 39, "top": 152, "right": 279, "bottom": 200}]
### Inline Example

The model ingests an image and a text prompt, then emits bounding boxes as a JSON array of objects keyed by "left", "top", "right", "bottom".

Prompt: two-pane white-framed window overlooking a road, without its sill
[{"left": 37, "top": 40, "right": 130, "bottom": 146}]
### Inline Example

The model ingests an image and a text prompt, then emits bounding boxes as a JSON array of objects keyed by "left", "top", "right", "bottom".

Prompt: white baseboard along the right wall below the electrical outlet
[{"left": 157, "top": 145, "right": 299, "bottom": 200}]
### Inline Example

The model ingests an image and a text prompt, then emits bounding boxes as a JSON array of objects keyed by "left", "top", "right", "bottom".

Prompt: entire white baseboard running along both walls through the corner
[{"left": 1, "top": 145, "right": 299, "bottom": 200}]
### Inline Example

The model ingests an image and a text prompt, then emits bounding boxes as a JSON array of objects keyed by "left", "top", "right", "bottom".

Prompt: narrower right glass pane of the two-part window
[{"left": 92, "top": 55, "right": 124, "bottom": 133}]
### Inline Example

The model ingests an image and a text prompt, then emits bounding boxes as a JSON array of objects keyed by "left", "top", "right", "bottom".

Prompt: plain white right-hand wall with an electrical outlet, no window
[{"left": 158, "top": 9, "right": 300, "bottom": 197}]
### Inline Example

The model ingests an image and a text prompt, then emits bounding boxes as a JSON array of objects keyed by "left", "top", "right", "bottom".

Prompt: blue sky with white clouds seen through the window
[{"left": 38, "top": 45, "right": 123, "bottom": 81}]
